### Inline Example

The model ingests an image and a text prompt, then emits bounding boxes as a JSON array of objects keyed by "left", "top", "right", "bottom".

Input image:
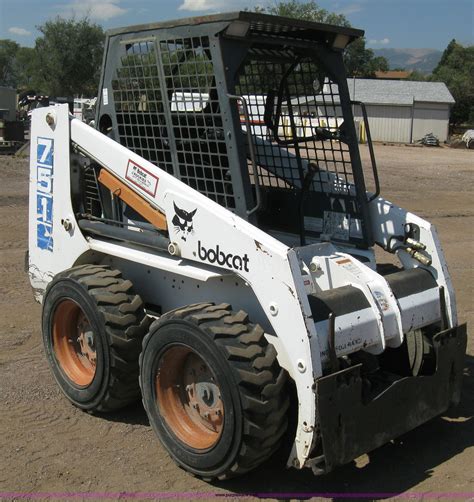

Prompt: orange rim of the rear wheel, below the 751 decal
[{"left": 53, "top": 299, "right": 97, "bottom": 387}]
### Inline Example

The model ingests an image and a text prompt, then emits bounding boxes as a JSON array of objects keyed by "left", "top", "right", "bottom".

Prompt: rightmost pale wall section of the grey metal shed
[{"left": 413, "top": 103, "right": 449, "bottom": 141}]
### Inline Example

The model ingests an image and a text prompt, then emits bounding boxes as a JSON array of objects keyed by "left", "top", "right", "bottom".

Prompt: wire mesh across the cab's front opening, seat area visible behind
[{"left": 236, "top": 48, "right": 362, "bottom": 240}]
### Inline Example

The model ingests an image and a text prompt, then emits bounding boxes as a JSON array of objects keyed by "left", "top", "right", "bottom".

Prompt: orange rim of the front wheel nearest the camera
[{"left": 155, "top": 345, "right": 224, "bottom": 450}]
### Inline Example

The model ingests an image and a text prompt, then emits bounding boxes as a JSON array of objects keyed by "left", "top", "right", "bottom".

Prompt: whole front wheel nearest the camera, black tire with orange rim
[{"left": 140, "top": 303, "right": 289, "bottom": 480}]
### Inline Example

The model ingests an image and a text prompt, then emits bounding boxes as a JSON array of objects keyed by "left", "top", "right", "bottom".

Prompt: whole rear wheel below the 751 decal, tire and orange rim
[{"left": 42, "top": 265, "right": 150, "bottom": 412}]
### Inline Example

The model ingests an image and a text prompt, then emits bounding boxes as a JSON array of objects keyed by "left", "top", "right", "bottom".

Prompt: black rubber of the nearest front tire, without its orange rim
[{"left": 140, "top": 303, "right": 289, "bottom": 480}]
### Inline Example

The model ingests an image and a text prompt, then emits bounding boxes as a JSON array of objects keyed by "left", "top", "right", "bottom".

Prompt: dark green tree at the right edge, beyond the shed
[{"left": 430, "top": 40, "right": 474, "bottom": 124}]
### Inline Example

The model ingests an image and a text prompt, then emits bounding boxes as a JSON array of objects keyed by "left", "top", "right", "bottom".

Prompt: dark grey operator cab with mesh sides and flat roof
[{"left": 96, "top": 12, "right": 373, "bottom": 248}]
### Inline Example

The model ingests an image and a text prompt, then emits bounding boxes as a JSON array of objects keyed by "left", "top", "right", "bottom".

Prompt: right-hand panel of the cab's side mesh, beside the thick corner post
[{"left": 160, "top": 37, "right": 235, "bottom": 209}]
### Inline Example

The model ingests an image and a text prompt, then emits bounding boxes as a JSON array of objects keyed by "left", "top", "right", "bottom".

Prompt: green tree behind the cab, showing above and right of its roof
[{"left": 255, "top": 0, "right": 389, "bottom": 77}]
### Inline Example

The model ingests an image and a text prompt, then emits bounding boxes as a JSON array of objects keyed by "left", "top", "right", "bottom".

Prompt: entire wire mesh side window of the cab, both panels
[{"left": 112, "top": 37, "right": 235, "bottom": 209}]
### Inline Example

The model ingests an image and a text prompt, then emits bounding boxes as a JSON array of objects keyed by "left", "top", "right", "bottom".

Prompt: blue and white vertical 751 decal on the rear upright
[{"left": 36, "top": 138, "right": 54, "bottom": 251}]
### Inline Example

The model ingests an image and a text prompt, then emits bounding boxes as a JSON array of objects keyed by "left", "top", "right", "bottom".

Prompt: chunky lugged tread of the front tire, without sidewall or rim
[{"left": 140, "top": 303, "right": 289, "bottom": 480}]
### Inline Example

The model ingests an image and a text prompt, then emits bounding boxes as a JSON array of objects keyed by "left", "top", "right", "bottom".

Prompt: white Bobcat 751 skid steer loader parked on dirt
[{"left": 28, "top": 12, "right": 466, "bottom": 479}]
